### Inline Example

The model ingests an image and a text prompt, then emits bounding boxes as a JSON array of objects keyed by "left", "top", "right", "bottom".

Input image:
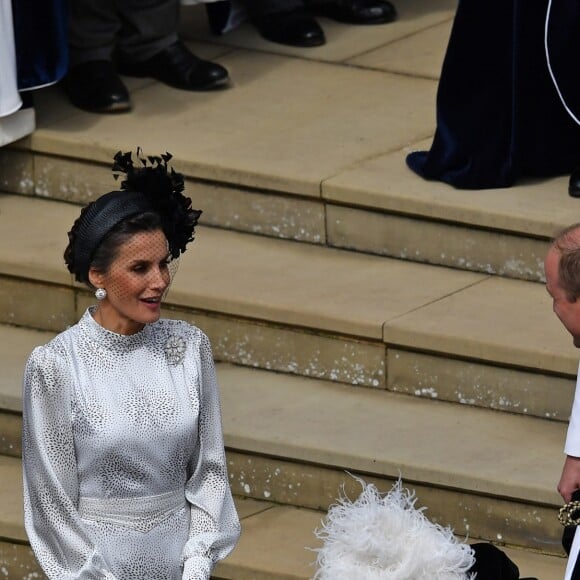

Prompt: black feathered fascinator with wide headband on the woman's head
[{"left": 64, "top": 149, "right": 201, "bottom": 282}]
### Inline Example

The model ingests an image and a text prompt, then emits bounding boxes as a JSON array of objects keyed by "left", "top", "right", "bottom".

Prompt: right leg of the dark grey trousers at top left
[{"left": 118, "top": 0, "right": 179, "bottom": 62}]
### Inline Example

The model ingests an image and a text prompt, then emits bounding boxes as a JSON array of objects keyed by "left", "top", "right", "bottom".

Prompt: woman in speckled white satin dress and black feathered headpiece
[{"left": 23, "top": 154, "right": 240, "bottom": 580}]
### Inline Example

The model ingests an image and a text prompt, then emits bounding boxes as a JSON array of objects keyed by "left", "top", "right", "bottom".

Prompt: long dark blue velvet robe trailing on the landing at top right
[{"left": 407, "top": 0, "right": 580, "bottom": 189}]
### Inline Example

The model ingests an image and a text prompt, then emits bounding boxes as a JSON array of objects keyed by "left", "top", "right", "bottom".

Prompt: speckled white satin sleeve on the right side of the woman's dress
[{"left": 183, "top": 334, "right": 240, "bottom": 580}]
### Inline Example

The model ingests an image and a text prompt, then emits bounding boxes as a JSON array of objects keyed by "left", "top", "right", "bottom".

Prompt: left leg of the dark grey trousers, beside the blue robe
[{"left": 69, "top": 0, "right": 121, "bottom": 66}]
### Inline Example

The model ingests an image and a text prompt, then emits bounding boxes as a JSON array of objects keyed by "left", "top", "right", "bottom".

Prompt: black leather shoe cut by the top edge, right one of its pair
[{"left": 306, "top": 0, "right": 397, "bottom": 24}]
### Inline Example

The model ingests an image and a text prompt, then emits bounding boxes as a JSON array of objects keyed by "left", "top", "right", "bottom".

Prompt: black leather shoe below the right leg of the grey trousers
[{"left": 118, "top": 41, "right": 229, "bottom": 91}]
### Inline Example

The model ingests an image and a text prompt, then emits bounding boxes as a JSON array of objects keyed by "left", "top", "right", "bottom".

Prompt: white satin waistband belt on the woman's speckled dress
[{"left": 78, "top": 489, "right": 186, "bottom": 533}]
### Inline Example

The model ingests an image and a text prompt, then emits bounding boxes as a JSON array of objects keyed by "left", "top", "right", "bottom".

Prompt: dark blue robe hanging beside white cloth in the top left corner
[{"left": 12, "top": 0, "right": 67, "bottom": 90}]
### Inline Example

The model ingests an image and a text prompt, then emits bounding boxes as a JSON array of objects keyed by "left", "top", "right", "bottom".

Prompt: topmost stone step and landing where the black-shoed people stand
[{"left": 0, "top": 0, "right": 577, "bottom": 280}]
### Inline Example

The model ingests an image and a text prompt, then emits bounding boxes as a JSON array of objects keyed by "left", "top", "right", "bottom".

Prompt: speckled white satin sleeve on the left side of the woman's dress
[{"left": 23, "top": 346, "right": 115, "bottom": 580}]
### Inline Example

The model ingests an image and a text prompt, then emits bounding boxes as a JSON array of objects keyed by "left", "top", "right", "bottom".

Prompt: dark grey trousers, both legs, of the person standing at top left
[{"left": 69, "top": 0, "right": 179, "bottom": 66}]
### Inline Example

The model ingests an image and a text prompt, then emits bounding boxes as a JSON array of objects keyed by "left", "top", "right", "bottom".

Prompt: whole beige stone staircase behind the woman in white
[{"left": 0, "top": 0, "right": 580, "bottom": 580}]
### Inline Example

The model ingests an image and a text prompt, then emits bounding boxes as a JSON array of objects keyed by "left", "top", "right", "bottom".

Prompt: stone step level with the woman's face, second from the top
[{"left": 0, "top": 195, "right": 577, "bottom": 420}]
